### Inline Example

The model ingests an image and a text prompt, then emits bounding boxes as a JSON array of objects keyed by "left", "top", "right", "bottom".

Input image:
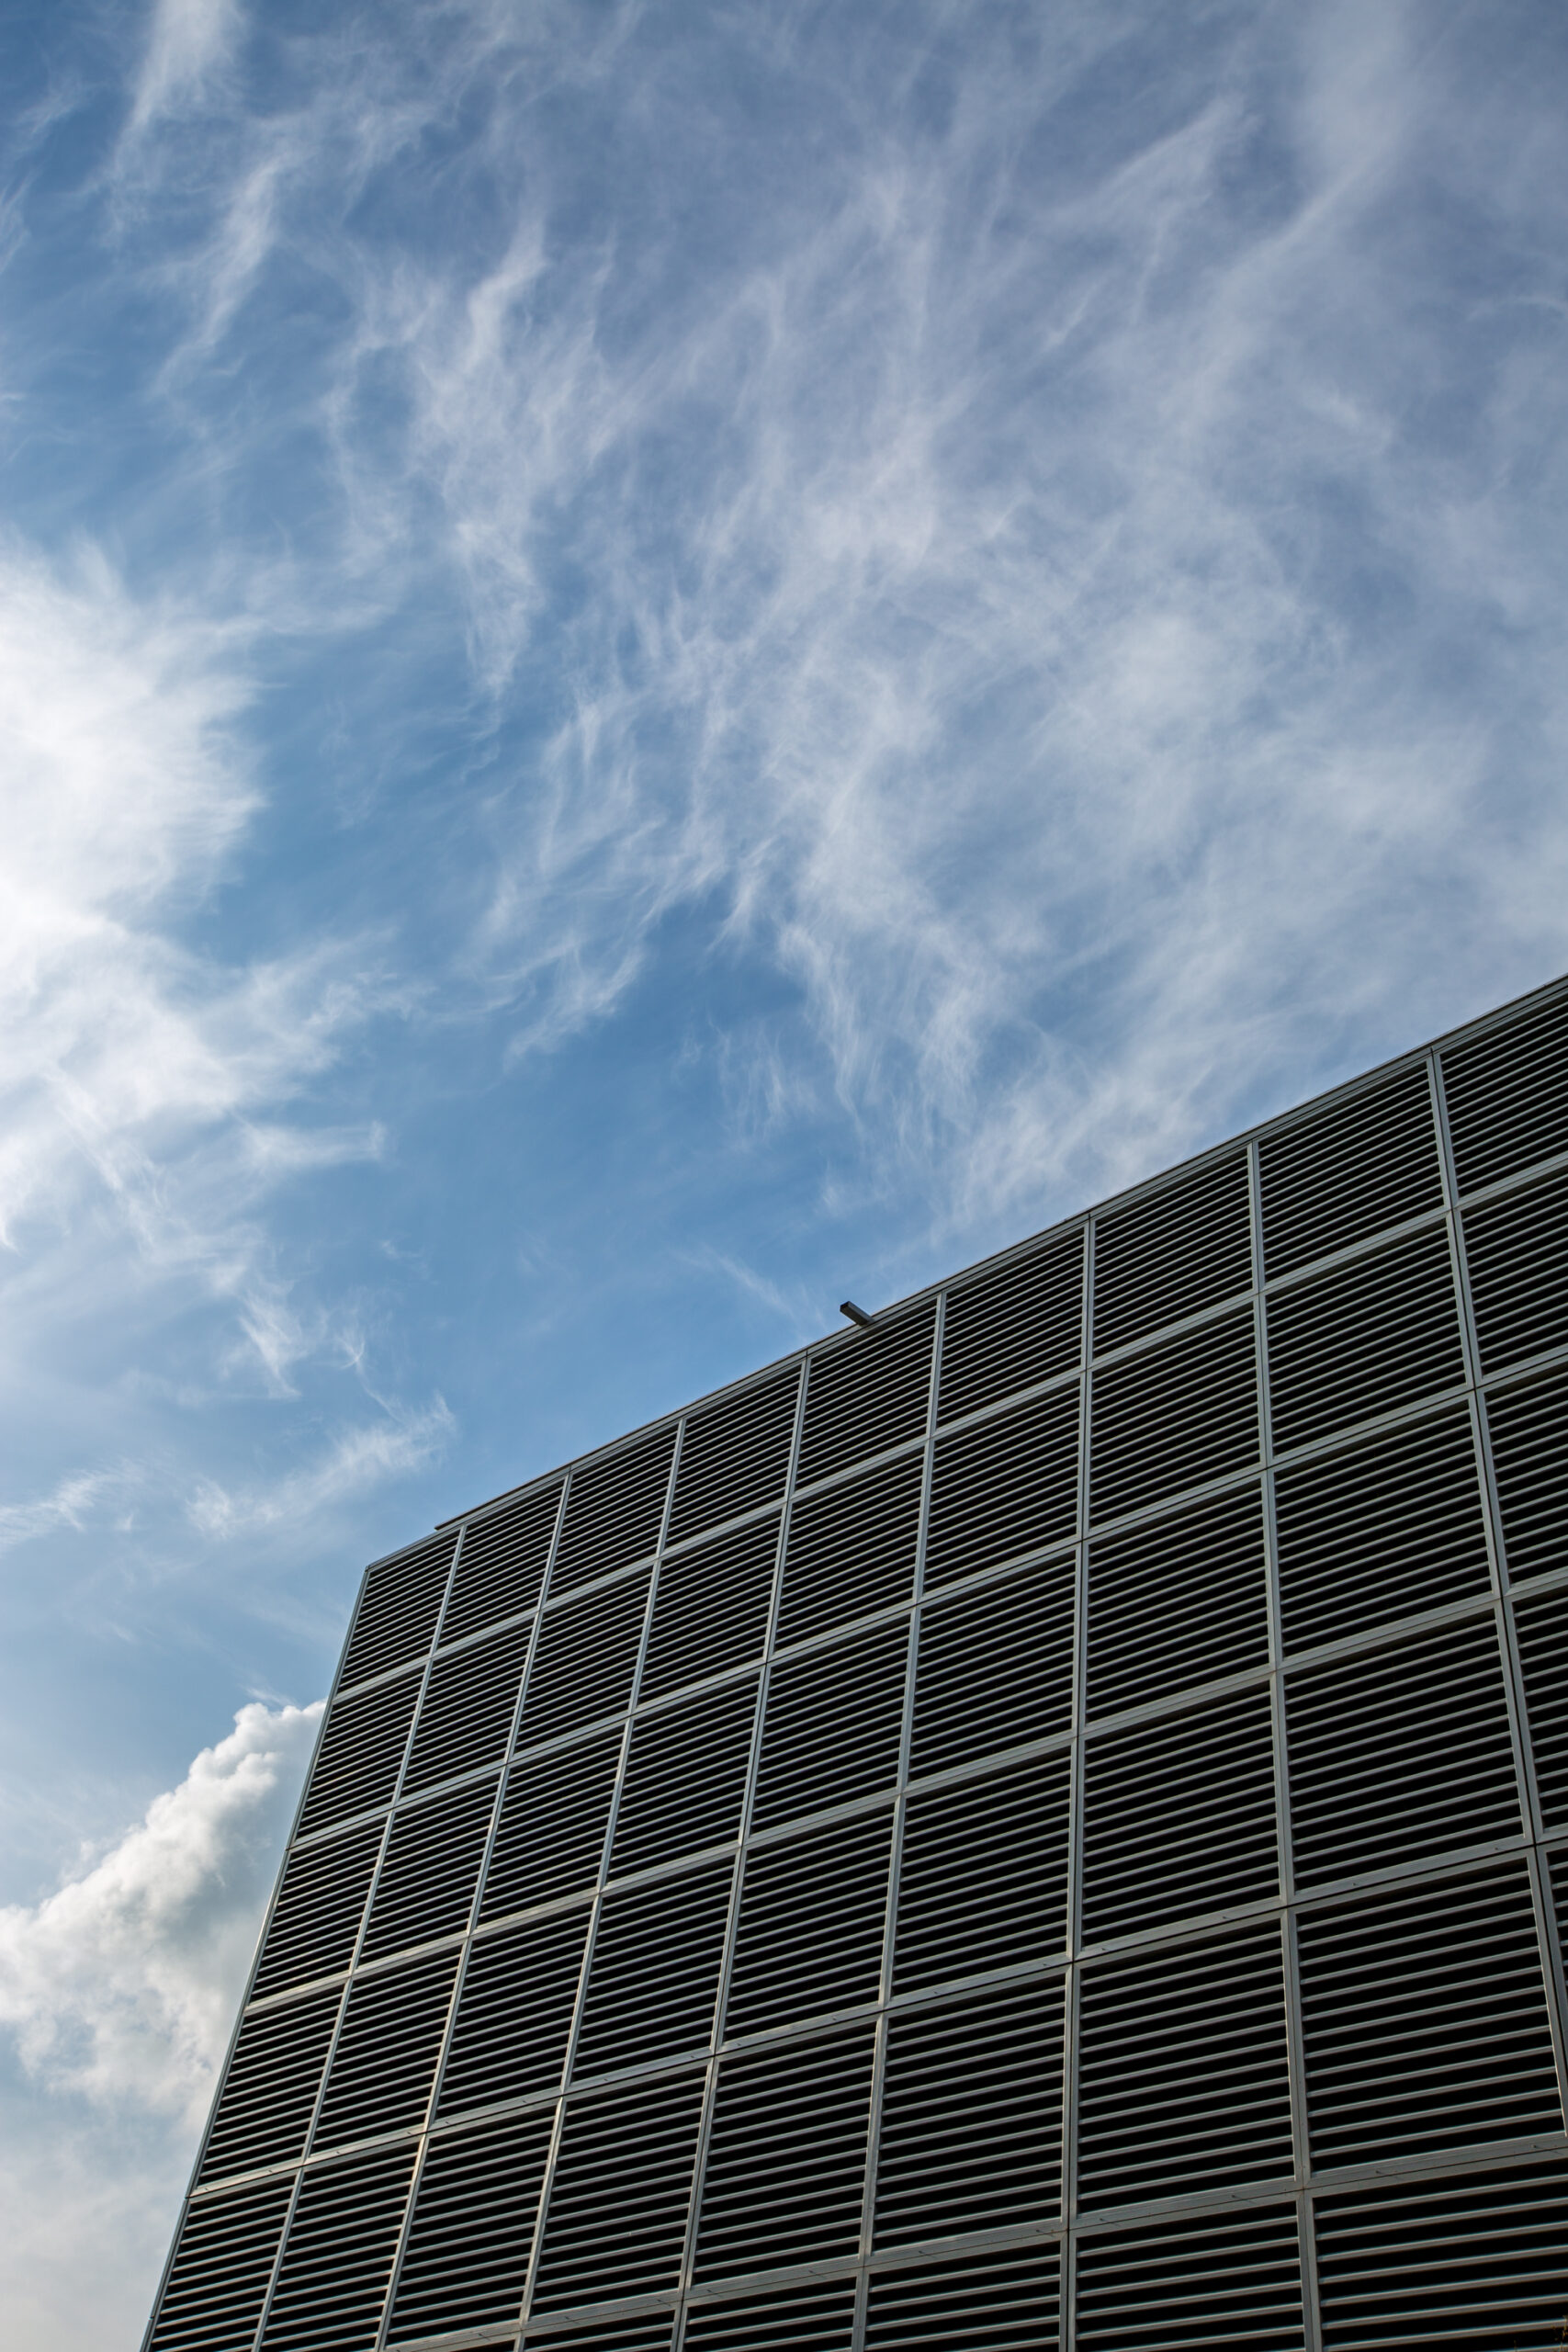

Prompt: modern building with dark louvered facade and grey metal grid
[{"left": 148, "top": 983, "right": 1568, "bottom": 2352}]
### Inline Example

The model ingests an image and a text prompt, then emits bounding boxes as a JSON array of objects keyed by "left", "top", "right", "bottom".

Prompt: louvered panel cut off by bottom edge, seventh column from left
[{"left": 1077, "top": 2206, "right": 1304, "bottom": 2352}]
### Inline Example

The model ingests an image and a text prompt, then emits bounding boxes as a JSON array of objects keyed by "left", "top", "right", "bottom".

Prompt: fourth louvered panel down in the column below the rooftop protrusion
[{"left": 724, "top": 1806, "right": 894, "bottom": 2041}]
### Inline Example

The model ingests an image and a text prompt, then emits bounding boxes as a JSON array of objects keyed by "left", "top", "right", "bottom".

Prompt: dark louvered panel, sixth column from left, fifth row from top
[{"left": 877, "top": 1978, "right": 1063, "bottom": 2246}]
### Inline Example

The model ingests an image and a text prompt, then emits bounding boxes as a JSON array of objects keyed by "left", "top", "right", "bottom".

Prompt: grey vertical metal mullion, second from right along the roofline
[{"left": 1246, "top": 1141, "right": 1321, "bottom": 2352}]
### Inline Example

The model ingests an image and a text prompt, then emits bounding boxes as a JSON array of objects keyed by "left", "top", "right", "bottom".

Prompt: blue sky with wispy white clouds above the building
[{"left": 0, "top": 0, "right": 1568, "bottom": 2352}]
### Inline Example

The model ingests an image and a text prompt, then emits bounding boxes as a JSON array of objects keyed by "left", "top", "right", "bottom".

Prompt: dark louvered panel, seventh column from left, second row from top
[{"left": 1090, "top": 1312, "right": 1258, "bottom": 1524}]
